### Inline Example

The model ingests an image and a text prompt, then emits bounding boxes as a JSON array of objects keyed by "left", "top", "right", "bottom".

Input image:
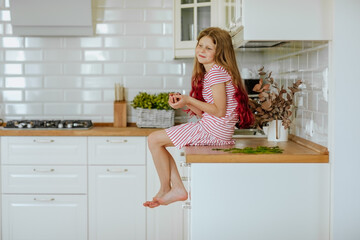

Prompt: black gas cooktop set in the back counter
[{"left": 5, "top": 120, "right": 93, "bottom": 129}]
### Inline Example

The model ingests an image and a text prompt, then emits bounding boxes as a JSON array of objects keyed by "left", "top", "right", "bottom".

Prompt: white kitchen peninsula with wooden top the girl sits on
[{"left": 185, "top": 136, "right": 330, "bottom": 240}]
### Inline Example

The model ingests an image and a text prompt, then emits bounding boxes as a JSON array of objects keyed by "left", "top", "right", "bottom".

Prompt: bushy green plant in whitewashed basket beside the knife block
[{"left": 131, "top": 92, "right": 175, "bottom": 128}]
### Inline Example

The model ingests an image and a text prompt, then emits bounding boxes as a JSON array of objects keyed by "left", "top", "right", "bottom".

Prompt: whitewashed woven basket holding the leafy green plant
[{"left": 136, "top": 108, "right": 175, "bottom": 128}]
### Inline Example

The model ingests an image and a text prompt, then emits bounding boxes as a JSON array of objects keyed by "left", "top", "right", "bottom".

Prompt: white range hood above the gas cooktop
[{"left": 10, "top": 0, "right": 94, "bottom": 36}]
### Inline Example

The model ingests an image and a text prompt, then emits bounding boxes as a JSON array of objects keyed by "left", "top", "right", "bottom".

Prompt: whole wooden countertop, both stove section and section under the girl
[{"left": 0, "top": 123, "right": 329, "bottom": 163}]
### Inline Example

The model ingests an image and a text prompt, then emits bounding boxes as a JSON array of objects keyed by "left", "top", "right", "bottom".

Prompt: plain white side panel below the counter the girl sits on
[{"left": 191, "top": 163, "right": 330, "bottom": 240}]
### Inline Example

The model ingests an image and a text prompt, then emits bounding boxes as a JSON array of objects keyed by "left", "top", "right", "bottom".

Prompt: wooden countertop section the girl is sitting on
[{"left": 185, "top": 135, "right": 329, "bottom": 163}]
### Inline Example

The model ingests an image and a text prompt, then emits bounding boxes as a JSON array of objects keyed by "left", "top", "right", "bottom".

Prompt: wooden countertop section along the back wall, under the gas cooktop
[{"left": 0, "top": 123, "right": 160, "bottom": 137}]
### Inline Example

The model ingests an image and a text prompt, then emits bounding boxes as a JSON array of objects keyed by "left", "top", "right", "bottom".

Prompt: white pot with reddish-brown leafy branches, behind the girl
[{"left": 249, "top": 67, "right": 302, "bottom": 141}]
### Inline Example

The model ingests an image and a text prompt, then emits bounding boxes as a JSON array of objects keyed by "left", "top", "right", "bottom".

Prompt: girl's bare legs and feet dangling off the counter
[{"left": 144, "top": 130, "right": 187, "bottom": 208}]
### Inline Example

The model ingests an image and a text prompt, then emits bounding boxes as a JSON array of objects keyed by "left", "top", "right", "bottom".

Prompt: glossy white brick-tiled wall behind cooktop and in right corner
[{"left": 0, "top": 0, "right": 328, "bottom": 145}]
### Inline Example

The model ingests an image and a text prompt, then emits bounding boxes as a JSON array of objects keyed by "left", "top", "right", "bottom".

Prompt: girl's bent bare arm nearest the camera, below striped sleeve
[{"left": 172, "top": 83, "right": 226, "bottom": 117}]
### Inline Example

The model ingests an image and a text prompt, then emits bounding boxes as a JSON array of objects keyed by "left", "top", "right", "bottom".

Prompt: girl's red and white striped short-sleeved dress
[{"left": 165, "top": 64, "right": 239, "bottom": 148}]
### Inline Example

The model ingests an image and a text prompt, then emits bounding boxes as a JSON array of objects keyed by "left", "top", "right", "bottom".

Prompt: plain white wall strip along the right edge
[{"left": 330, "top": 0, "right": 360, "bottom": 240}]
